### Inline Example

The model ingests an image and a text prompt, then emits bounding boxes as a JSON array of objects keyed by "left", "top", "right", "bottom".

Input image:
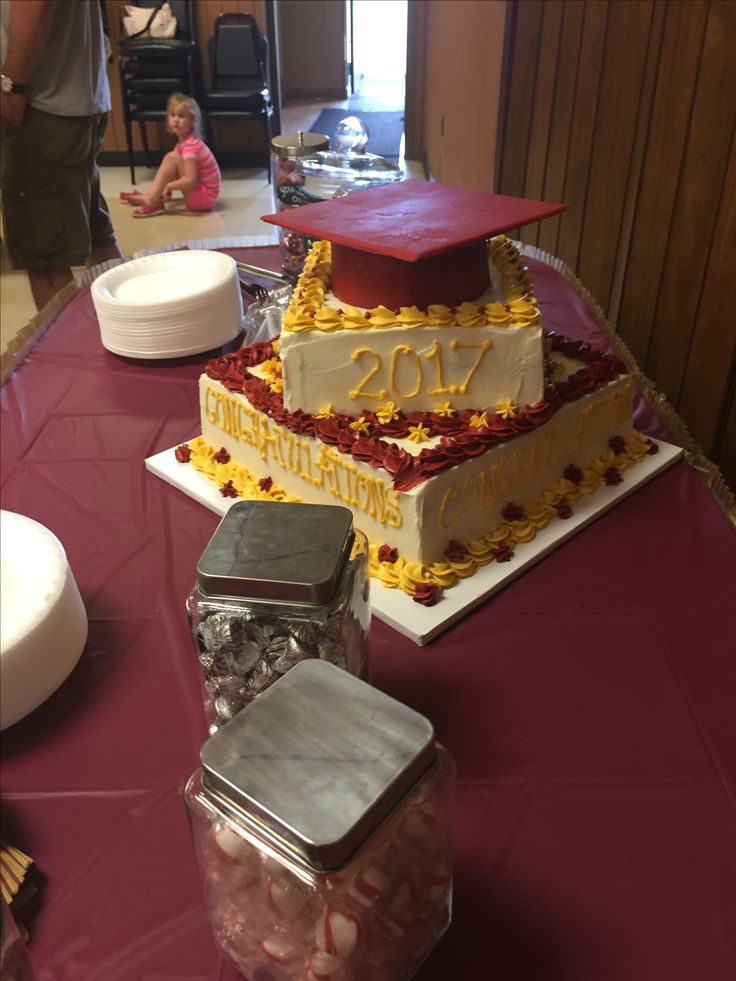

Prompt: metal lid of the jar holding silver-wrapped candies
[{"left": 197, "top": 501, "right": 355, "bottom": 606}]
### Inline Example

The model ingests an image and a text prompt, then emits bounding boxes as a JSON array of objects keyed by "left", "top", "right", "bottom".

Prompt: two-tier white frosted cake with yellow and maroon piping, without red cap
[{"left": 176, "top": 185, "right": 651, "bottom": 603}]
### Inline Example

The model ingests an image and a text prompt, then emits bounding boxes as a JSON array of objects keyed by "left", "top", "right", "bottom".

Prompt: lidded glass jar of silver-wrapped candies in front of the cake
[{"left": 187, "top": 501, "right": 370, "bottom": 732}]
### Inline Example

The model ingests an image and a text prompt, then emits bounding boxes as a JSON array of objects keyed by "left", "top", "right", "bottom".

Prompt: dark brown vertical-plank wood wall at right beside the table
[{"left": 498, "top": 0, "right": 736, "bottom": 486}]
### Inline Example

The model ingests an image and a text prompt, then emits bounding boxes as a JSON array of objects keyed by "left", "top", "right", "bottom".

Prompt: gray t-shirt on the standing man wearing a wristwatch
[{"left": 0, "top": 0, "right": 110, "bottom": 116}]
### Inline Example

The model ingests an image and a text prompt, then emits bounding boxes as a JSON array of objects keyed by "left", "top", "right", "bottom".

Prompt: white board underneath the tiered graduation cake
[{"left": 146, "top": 439, "right": 682, "bottom": 645}]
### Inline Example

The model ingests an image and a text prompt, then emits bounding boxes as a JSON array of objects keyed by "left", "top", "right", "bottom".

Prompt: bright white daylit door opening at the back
[{"left": 346, "top": 0, "right": 409, "bottom": 109}]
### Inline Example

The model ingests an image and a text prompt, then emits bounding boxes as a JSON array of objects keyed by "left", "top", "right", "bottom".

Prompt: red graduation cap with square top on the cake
[{"left": 263, "top": 180, "right": 567, "bottom": 308}]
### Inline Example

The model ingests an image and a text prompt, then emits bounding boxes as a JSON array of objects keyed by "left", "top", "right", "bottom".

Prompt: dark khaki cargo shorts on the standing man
[{"left": 0, "top": 106, "right": 115, "bottom": 269}]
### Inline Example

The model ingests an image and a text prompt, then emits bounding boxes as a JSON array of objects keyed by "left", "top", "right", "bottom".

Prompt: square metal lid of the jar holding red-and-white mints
[{"left": 200, "top": 659, "right": 436, "bottom": 871}]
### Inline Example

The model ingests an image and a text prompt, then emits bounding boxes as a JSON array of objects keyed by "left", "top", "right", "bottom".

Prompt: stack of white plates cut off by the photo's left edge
[{"left": 0, "top": 511, "right": 87, "bottom": 729}]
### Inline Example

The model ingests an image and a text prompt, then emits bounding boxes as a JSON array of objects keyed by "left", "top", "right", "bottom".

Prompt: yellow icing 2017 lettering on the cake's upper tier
[{"left": 348, "top": 338, "right": 491, "bottom": 401}]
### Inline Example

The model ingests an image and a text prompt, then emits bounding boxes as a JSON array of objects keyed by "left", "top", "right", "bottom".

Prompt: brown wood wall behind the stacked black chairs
[{"left": 102, "top": 0, "right": 265, "bottom": 159}]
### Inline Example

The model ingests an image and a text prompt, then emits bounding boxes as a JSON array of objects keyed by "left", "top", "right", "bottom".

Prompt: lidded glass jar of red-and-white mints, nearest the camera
[{"left": 185, "top": 661, "right": 455, "bottom": 981}]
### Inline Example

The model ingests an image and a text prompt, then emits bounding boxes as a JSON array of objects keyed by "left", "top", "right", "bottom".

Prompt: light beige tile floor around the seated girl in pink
[{"left": 0, "top": 99, "right": 425, "bottom": 351}]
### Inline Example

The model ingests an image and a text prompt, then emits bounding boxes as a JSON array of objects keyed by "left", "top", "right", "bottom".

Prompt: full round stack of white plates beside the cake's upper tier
[{"left": 91, "top": 249, "right": 243, "bottom": 358}]
